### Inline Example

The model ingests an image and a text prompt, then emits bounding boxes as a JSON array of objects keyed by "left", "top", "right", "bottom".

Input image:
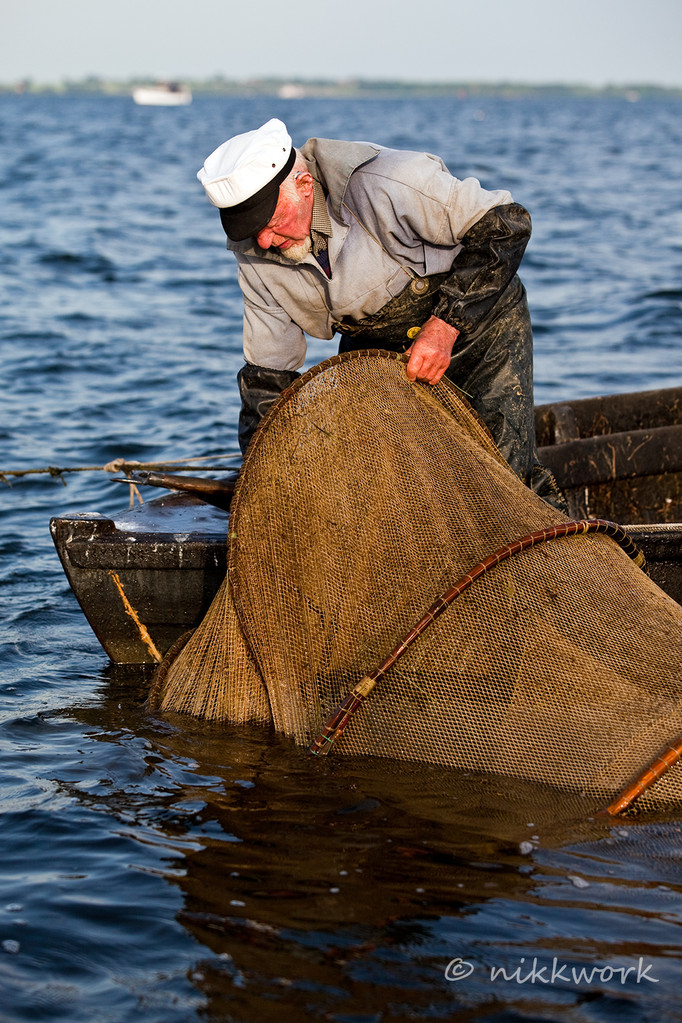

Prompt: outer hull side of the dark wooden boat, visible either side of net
[{"left": 50, "top": 515, "right": 682, "bottom": 664}]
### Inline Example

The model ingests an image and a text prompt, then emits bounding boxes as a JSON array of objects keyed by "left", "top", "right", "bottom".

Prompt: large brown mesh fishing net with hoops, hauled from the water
[{"left": 150, "top": 352, "right": 682, "bottom": 807}]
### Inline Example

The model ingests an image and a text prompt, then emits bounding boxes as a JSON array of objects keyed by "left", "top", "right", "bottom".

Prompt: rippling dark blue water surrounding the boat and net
[{"left": 0, "top": 96, "right": 682, "bottom": 1023}]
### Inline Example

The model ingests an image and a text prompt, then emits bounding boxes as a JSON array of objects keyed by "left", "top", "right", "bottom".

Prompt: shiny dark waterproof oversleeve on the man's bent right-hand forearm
[{"left": 433, "top": 203, "right": 531, "bottom": 333}]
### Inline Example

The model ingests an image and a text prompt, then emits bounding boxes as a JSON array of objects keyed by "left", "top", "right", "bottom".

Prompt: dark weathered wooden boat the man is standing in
[{"left": 50, "top": 387, "right": 682, "bottom": 664}]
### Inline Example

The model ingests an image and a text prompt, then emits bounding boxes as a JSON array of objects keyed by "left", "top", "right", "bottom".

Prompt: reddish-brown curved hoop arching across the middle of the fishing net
[{"left": 310, "top": 519, "right": 645, "bottom": 757}]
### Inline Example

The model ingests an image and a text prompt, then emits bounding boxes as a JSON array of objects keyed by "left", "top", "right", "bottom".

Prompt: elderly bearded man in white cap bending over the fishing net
[{"left": 197, "top": 119, "right": 562, "bottom": 506}]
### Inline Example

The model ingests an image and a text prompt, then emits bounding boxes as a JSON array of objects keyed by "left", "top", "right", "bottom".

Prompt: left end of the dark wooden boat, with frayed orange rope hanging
[{"left": 50, "top": 494, "right": 229, "bottom": 664}]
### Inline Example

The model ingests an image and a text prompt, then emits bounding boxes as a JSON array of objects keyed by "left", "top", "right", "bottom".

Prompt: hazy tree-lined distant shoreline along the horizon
[{"left": 0, "top": 78, "right": 682, "bottom": 102}]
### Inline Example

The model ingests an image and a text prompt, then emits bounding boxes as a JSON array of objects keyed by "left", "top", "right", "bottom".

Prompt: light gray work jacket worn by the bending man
[{"left": 227, "top": 138, "right": 512, "bottom": 370}]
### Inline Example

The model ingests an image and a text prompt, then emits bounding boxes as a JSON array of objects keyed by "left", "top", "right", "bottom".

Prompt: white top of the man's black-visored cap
[{"left": 196, "top": 118, "right": 291, "bottom": 208}]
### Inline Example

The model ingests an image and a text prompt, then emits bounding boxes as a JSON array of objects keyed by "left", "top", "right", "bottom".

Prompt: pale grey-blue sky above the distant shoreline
[{"left": 0, "top": 0, "right": 682, "bottom": 86}]
